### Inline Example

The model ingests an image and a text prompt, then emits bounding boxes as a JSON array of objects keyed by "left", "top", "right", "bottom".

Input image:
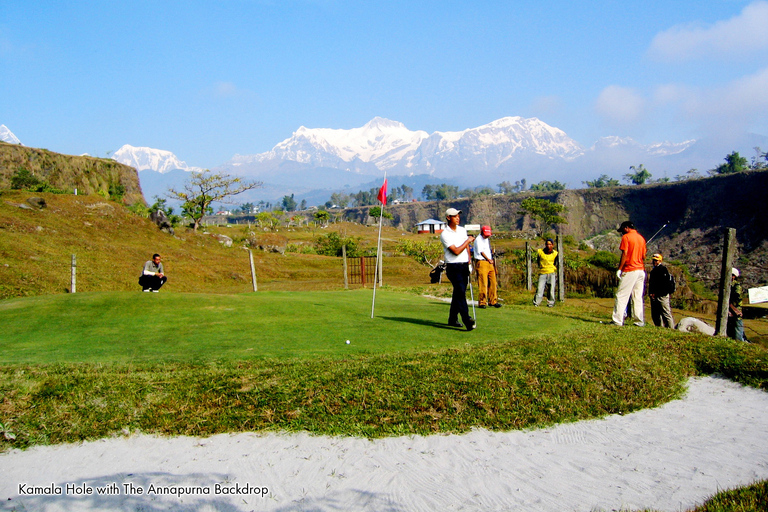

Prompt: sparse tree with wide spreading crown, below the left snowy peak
[{"left": 167, "top": 169, "right": 262, "bottom": 231}]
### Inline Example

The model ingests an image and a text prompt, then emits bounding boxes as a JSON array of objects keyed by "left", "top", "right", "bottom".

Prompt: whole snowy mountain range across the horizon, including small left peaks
[{"left": 0, "top": 117, "right": 768, "bottom": 204}]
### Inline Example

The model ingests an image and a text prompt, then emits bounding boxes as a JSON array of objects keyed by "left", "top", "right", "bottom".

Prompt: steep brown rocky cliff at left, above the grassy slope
[{"left": 0, "top": 142, "right": 145, "bottom": 204}]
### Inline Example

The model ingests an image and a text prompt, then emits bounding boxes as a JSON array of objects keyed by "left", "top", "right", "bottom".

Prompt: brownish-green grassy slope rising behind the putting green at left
[{"left": 0, "top": 191, "right": 428, "bottom": 299}]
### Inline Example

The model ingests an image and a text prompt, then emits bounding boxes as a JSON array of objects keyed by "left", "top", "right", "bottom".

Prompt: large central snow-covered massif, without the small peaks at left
[{"left": 225, "top": 117, "right": 583, "bottom": 174}]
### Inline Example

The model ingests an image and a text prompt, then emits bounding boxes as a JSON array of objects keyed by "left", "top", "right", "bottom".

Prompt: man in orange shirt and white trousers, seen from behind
[{"left": 612, "top": 220, "right": 645, "bottom": 327}]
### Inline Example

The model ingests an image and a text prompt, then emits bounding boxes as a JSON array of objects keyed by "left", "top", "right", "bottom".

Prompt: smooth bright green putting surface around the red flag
[{"left": 0, "top": 289, "right": 582, "bottom": 364}]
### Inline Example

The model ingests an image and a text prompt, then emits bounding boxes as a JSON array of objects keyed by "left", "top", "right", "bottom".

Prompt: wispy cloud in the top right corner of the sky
[{"left": 648, "top": 0, "right": 768, "bottom": 62}]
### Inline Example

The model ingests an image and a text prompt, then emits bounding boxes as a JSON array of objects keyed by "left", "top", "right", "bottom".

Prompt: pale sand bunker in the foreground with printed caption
[{"left": 0, "top": 377, "right": 768, "bottom": 512}]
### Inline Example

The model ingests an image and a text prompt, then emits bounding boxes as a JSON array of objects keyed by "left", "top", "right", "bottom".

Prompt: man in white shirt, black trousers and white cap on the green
[{"left": 440, "top": 208, "right": 475, "bottom": 331}]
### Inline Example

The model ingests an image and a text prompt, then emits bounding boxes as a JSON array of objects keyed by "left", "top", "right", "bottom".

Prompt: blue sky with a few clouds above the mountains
[{"left": 0, "top": 0, "right": 768, "bottom": 167}]
